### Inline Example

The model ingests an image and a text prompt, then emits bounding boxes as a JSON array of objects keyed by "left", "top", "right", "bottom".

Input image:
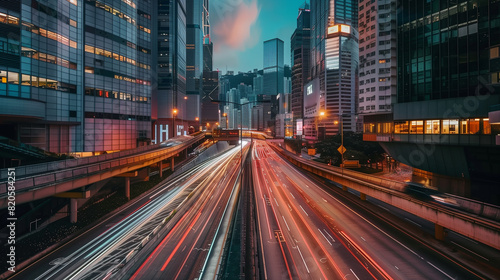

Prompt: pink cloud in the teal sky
[{"left": 212, "top": 0, "right": 260, "bottom": 50}]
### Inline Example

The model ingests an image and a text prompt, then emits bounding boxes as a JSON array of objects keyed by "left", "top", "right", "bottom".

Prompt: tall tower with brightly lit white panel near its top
[{"left": 304, "top": 0, "right": 359, "bottom": 140}]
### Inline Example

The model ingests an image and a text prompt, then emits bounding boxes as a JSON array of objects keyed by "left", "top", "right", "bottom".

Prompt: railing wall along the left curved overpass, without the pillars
[{"left": 0, "top": 133, "right": 205, "bottom": 208}]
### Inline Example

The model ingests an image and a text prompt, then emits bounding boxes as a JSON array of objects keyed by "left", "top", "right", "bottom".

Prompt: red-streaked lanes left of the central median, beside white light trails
[{"left": 125, "top": 143, "right": 245, "bottom": 280}]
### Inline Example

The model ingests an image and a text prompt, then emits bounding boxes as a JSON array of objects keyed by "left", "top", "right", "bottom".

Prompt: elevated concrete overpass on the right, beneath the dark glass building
[{"left": 270, "top": 145, "right": 500, "bottom": 250}]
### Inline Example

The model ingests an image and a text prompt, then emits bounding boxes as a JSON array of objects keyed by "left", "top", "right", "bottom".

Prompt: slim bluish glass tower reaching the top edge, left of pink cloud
[{"left": 185, "top": 0, "right": 204, "bottom": 125}]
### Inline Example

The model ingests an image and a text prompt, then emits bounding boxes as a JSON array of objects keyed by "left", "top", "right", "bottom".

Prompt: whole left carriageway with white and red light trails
[{"left": 12, "top": 144, "right": 245, "bottom": 280}]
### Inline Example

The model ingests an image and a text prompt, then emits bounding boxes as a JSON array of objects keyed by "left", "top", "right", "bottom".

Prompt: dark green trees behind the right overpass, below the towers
[{"left": 315, "top": 132, "right": 385, "bottom": 165}]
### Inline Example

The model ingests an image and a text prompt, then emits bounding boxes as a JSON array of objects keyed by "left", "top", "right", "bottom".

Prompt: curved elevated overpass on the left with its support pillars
[{"left": 0, "top": 133, "right": 205, "bottom": 221}]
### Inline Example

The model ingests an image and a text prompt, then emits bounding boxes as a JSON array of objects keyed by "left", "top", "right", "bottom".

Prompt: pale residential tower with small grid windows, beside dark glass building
[{"left": 358, "top": 0, "right": 397, "bottom": 129}]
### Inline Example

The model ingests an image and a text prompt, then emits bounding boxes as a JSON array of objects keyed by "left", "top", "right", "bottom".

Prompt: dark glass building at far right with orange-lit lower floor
[{"left": 364, "top": 0, "right": 500, "bottom": 203}]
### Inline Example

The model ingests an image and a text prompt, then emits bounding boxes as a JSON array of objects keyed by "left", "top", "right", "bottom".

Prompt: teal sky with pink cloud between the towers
[{"left": 210, "top": 0, "right": 309, "bottom": 74}]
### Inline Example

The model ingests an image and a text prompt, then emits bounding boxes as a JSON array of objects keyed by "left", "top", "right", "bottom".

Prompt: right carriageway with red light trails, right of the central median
[{"left": 252, "top": 141, "right": 481, "bottom": 279}]
